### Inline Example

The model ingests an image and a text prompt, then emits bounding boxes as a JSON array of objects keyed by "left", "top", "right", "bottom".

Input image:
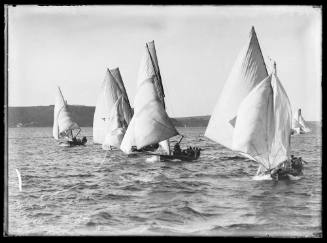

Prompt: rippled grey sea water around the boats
[{"left": 8, "top": 123, "right": 322, "bottom": 237}]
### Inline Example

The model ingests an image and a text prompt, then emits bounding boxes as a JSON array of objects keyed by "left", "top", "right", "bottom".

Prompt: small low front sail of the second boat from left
[{"left": 102, "top": 96, "right": 126, "bottom": 150}]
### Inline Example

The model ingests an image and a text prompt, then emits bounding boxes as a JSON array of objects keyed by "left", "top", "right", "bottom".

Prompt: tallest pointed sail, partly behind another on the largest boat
[{"left": 204, "top": 27, "right": 268, "bottom": 149}]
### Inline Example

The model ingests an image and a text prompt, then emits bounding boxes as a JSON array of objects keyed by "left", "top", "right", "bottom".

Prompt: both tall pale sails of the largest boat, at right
[{"left": 205, "top": 27, "right": 292, "bottom": 176}]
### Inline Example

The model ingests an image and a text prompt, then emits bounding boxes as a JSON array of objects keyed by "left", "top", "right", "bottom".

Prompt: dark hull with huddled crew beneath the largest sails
[{"left": 270, "top": 155, "right": 305, "bottom": 180}]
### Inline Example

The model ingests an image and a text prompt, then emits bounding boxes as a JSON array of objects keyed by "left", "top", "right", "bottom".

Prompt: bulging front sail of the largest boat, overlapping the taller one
[{"left": 232, "top": 67, "right": 292, "bottom": 170}]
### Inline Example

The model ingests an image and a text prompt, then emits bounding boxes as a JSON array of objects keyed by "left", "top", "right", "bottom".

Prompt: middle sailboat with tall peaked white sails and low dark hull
[{"left": 120, "top": 41, "right": 199, "bottom": 160}]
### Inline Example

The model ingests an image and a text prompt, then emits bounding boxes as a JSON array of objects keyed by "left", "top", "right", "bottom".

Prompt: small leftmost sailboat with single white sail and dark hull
[{"left": 52, "top": 87, "right": 86, "bottom": 147}]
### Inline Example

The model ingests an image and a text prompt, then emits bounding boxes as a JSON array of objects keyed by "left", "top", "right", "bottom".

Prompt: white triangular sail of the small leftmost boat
[{"left": 53, "top": 87, "right": 80, "bottom": 139}]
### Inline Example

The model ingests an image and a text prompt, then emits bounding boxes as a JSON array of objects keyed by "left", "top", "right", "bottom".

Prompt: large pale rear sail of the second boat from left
[{"left": 93, "top": 69, "right": 125, "bottom": 144}]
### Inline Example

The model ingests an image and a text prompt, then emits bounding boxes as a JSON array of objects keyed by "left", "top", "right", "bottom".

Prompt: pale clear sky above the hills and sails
[{"left": 8, "top": 5, "right": 322, "bottom": 121}]
